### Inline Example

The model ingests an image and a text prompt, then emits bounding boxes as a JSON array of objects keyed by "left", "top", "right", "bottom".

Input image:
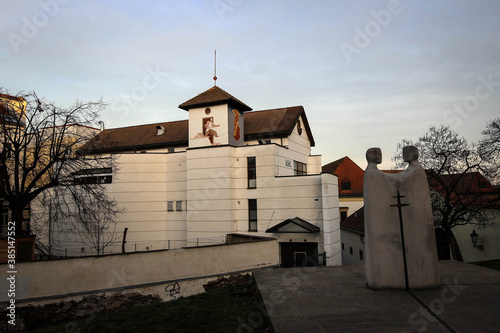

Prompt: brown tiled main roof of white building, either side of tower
[{"left": 81, "top": 106, "right": 314, "bottom": 154}]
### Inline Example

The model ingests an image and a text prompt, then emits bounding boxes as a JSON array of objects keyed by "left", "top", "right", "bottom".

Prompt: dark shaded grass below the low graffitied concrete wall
[{"left": 29, "top": 278, "right": 271, "bottom": 333}]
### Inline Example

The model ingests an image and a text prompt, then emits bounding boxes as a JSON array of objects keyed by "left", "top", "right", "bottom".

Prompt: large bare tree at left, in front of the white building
[{"left": 0, "top": 92, "right": 119, "bottom": 255}]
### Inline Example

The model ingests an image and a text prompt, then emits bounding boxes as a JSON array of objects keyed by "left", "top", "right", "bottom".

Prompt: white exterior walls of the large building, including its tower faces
[{"left": 34, "top": 105, "right": 340, "bottom": 264}]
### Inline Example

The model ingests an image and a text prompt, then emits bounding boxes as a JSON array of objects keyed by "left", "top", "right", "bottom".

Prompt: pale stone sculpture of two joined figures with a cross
[{"left": 363, "top": 146, "right": 439, "bottom": 289}]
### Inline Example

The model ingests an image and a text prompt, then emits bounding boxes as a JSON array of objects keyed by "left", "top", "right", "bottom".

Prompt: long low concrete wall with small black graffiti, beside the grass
[{"left": 0, "top": 240, "right": 278, "bottom": 303}]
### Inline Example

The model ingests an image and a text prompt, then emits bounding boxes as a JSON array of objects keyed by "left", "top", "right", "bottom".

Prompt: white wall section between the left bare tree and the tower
[{"left": 107, "top": 153, "right": 186, "bottom": 251}]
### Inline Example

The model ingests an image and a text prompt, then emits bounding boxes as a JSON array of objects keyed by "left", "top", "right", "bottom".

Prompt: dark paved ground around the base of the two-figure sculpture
[{"left": 254, "top": 261, "right": 500, "bottom": 333}]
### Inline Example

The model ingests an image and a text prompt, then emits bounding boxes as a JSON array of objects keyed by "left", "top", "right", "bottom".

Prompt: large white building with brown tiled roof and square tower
[{"left": 47, "top": 86, "right": 341, "bottom": 266}]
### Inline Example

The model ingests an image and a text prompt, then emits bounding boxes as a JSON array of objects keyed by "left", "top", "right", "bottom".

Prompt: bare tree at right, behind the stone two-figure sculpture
[{"left": 392, "top": 126, "right": 500, "bottom": 260}]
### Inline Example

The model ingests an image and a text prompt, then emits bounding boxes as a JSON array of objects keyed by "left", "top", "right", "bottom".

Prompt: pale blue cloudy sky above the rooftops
[{"left": 0, "top": 0, "right": 500, "bottom": 169}]
